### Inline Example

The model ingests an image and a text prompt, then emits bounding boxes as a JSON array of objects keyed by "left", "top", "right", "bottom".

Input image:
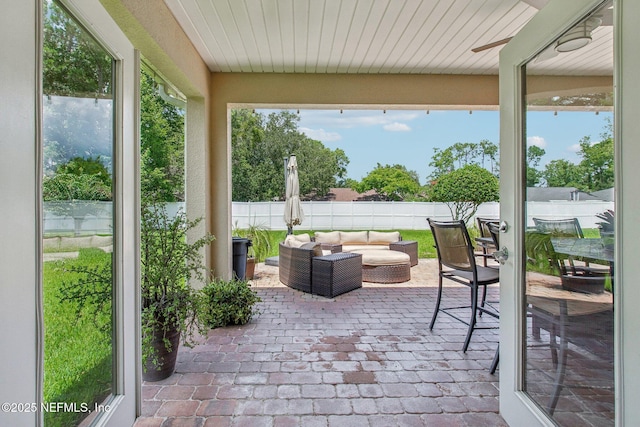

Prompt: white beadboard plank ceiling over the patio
[{"left": 165, "top": 0, "right": 613, "bottom": 75}]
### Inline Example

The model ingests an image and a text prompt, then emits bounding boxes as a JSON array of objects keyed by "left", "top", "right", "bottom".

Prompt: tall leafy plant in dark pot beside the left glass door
[{"left": 140, "top": 200, "right": 214, "bottom": 381}]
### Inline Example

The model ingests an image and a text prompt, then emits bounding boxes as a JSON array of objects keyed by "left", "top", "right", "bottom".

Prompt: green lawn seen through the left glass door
[{"left": 43, "top": 249, "right": 112, "bottom": 427}]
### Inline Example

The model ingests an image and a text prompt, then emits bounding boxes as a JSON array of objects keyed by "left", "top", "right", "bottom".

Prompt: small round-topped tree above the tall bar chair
[{"left": 431, "top": 165, "right": 500, "bottom": 223}]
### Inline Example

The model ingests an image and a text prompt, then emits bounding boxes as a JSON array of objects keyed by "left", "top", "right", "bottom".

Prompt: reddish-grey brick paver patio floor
[{"left": 135, "top": 259, "right": 506, "bottom": 427}]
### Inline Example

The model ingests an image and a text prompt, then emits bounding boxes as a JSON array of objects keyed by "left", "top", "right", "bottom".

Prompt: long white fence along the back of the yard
[{"left": 44, "top": 201, "right": 614, "bottom": 236}]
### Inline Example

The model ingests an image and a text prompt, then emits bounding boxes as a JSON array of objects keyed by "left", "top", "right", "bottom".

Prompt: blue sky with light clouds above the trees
[{"left": 259, "top": 109, "right": 612, "bottom": 184}]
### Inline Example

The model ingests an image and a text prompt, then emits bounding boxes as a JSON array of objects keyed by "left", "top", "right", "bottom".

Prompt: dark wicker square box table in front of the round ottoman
[{"left": 311, "top": 252, "right": 362, "bottom": 298}]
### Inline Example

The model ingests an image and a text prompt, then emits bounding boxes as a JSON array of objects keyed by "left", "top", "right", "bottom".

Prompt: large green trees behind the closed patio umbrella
[{"left": 231, "top": 110, "right": 349, "bottom": 201}]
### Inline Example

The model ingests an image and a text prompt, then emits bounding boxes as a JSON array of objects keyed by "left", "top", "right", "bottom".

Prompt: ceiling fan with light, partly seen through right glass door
[{"left": 471, "top": 0, "right": 613, "bottom": 54}]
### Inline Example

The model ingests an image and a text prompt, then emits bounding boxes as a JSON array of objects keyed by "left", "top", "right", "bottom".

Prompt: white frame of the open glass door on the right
[{"left": 499, "top": 0, "right": 640, "bottom": 426}]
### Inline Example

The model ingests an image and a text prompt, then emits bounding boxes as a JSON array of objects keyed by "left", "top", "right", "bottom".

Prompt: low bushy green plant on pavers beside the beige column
[{"left": 201, "top": 279, "right": 262, "bottom": 328}]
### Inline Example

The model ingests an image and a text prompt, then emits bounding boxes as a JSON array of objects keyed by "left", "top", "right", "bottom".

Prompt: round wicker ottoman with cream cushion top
[{"left": 355, "top": 249, "right": 411, "bottom": 283}]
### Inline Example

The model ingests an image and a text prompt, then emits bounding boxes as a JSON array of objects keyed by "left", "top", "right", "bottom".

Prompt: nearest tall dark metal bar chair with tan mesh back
[{"left": 427, "top": 218, "right": 500, "bottom": 352}]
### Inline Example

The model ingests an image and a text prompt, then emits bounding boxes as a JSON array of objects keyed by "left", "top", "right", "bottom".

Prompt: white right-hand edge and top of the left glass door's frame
[{"left": 59, "top": 0, "right": 141, "bottom": 426}]
